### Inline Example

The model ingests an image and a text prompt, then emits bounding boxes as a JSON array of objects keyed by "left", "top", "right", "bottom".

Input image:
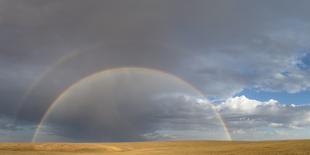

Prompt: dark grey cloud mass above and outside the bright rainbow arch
[{"left": 0, "top": 0, "right": 310, "bottom": 140}]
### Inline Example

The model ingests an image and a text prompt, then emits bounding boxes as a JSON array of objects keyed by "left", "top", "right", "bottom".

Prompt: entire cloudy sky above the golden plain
[{"left": 0, "top": 0, "right": 310, "bottom": 141}]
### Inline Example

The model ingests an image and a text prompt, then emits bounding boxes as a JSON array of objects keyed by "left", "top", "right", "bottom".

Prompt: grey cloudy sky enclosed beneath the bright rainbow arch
[{"left": 36, "top": 69, "right": 225, "bottom": 141}]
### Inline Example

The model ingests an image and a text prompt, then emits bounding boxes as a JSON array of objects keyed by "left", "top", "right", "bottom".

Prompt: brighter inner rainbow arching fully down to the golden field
[{"left": 32, "top": 67, "right": 232, "bottom": 142}]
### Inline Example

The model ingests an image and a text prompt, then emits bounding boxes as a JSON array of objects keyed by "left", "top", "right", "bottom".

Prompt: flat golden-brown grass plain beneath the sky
[{"left": 0, "top": 140, "right": 310, "bottom": 155}]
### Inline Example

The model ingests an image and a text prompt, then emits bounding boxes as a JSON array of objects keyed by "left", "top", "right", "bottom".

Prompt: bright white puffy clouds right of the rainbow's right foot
[{"left": 216, "top": 96, "right": 310, "bottom": 139}]
